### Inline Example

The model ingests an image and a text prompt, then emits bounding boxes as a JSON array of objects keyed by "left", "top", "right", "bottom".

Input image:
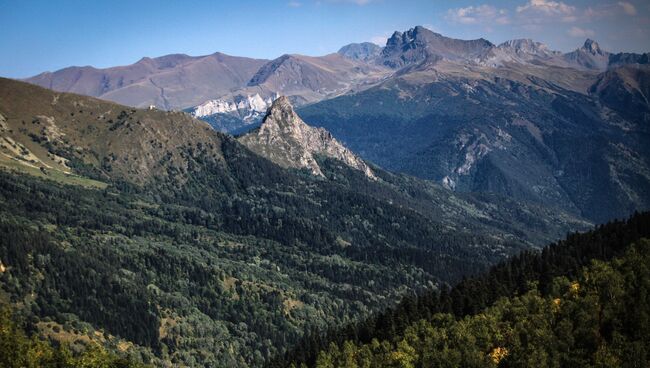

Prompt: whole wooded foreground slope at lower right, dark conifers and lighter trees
[{"left": 278, "top": 213, "right": 650, "bottom": 367}]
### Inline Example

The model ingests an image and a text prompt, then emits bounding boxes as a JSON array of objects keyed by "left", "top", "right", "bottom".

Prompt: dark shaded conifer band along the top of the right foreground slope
[{"left": 269, "top": 212, "right": 650, "bottom": 367}]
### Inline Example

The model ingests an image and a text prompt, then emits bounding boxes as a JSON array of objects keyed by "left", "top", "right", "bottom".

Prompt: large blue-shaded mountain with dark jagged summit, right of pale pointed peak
[{"left": 299, "top": 27, "right": 650, "bottom": 222}]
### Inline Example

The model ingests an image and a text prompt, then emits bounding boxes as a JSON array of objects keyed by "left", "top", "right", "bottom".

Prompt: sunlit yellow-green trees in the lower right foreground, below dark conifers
[{"left": 306, "top": 239, "right": 650, "bottom": 368}]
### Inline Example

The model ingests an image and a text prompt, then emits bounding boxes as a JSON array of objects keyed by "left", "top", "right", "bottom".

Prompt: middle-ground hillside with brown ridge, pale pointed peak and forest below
[{"left": 0, "top": 79, "right": 589, "bottom": 367}]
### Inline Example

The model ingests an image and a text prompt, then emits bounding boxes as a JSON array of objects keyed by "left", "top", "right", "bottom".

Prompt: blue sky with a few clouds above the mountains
[{"left": 0, "top": 0, "right": 650, "bottom": 78}]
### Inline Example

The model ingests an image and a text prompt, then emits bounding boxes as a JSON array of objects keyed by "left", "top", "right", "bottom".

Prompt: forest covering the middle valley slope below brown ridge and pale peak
[{"left": 0, "top": 122, "right": 582, "bottom": 366}]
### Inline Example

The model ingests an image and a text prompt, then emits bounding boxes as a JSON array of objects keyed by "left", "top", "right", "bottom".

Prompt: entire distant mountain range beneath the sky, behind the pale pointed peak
[{"left": 20, "top": 26, "right": 650, "bottom": 221}]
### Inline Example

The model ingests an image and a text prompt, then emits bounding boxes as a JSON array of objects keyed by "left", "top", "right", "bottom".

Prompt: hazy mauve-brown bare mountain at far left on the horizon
[{"left": 25, "top": 52, "right": 266, "bottom": 109}]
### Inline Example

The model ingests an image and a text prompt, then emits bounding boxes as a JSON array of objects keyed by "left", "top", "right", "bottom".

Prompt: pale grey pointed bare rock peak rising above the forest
[{"left": 239, "top": 96, "right": 376, "bottom": 179}]
